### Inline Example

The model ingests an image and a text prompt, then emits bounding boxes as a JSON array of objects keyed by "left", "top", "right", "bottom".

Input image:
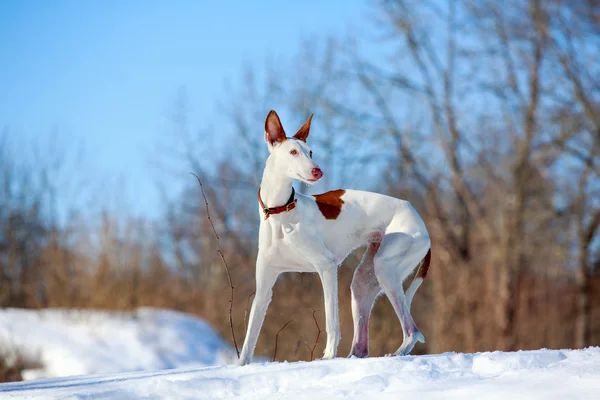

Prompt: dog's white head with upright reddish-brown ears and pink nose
[{"left": 265, "top": 110, "right": 323, "bottom": 185}]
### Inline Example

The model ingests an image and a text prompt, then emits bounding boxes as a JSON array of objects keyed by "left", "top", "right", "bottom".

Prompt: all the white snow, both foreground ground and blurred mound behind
[{"left": 0, "top": 309, "right": 600, "bottom": 400}]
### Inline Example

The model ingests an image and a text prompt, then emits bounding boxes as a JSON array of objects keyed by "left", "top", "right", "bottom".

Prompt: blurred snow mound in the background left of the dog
[{"left": 0, "top": 308, "right": 236, "bottom": 379}]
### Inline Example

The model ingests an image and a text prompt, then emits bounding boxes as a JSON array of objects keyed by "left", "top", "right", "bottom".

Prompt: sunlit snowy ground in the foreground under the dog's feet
[{"left": 0, "top": 348, "right": 600, "bottom": 400}]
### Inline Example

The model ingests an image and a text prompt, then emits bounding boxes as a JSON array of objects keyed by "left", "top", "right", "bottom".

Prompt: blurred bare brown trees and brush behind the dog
[{"left": 0, "top": 0, "right": 600, "bottom": 361}]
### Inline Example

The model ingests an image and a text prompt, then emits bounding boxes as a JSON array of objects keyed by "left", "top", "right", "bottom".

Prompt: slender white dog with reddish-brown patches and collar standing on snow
[{"left": 239, "top": 110, "right": 431, "bottom": 365}]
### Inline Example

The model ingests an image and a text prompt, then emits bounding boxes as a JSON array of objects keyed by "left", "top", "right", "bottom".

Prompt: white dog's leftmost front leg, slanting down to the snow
[{"left": 239, "top": 252, "right": 279, "bottom": 365}]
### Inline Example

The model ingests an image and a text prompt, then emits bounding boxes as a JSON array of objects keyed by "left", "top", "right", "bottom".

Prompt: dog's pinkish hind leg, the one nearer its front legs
[{"left": 349, "top": 232, "right": 383, "bottom": 358}]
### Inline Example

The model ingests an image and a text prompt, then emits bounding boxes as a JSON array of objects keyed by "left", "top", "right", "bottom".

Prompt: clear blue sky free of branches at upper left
[{"left": 0, "top": 0, "right": 367, "bottom": 219}]
